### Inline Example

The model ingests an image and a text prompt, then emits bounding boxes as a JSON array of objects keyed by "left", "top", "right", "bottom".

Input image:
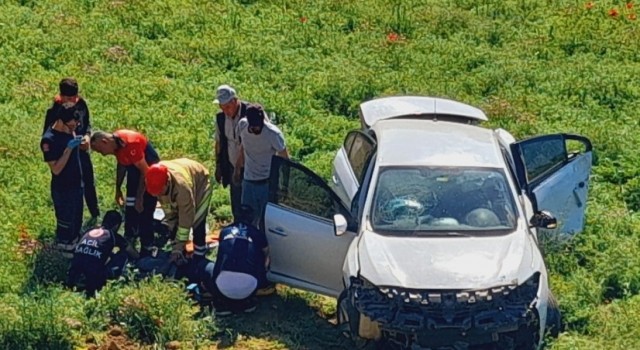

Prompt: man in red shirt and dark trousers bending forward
[{"left": 91, "top": 129, "right": 160, "bottom": 255}]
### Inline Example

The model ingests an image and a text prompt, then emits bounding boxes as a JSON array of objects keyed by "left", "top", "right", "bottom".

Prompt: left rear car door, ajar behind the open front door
[{"left": 331, "top": 130, "right": 375, "bottom": 208}]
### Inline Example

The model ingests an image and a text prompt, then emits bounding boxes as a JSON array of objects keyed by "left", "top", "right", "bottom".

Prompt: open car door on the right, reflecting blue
[{"left": 511, "top": 134, "right": 592, "bottom": 236}]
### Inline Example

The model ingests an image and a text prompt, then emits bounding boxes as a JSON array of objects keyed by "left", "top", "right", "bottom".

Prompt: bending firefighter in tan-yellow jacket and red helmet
[{"left": 145, "top": 158, "right": 212, "bottom": 261}]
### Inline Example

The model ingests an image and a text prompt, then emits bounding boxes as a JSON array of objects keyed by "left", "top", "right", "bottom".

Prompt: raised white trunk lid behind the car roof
[{"left": 360, "top": 96, "right": 487, "bottom": 128}]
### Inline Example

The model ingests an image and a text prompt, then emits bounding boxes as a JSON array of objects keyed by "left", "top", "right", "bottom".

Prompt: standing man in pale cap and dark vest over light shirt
[{"left": 213, "top": 85, "right": 268, "bottom": 219}]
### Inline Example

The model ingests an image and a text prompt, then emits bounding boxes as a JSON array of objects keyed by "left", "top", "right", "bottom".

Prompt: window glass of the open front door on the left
[{"left": 269, "top": 157, "right": 350, "bottom": 220}]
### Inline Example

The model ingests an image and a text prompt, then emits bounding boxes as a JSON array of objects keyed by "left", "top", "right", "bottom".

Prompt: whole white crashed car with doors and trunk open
[{"left": 264, "top": 96, "right": 592, "bottom": 349}]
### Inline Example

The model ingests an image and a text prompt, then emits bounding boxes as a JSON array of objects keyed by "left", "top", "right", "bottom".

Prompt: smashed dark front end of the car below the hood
[{"left": 349, "top": 273, "right": 540, "bottom": 349}]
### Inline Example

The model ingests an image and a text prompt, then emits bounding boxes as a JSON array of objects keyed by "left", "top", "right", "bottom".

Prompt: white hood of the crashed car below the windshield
[{"left": 358, "top": 231, "right": 540, "bottom": 289}]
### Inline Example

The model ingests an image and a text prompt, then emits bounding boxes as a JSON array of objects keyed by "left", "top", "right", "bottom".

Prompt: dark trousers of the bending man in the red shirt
[{"left": 124, "top": 166, "right": 158, "bottom": 248}]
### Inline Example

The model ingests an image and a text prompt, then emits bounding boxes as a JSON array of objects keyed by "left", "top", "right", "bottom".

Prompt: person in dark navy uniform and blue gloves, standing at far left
[{"left": 40, "top": 105, "right": 83, "bottom": 257}]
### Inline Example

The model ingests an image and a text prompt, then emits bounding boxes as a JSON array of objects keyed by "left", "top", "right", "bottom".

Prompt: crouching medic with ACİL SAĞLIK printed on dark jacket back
[{"left": 66, "top": 210, "right": 136, "bottom": 297}]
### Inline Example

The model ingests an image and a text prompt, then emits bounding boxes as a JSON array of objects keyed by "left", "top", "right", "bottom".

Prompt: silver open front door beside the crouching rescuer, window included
[{"left": 264, "top": 156, "right": 355, "bottom": 297}]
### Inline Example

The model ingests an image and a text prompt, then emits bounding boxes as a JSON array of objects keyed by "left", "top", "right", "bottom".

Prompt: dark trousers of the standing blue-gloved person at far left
[{"left": 51, "top": 184, "right": 83, "bottom": 244}]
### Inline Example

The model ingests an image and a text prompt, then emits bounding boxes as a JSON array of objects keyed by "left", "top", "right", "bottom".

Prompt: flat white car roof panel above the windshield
[{"left": 371, "top": 119, "right": 505, "bottom": 168}]
